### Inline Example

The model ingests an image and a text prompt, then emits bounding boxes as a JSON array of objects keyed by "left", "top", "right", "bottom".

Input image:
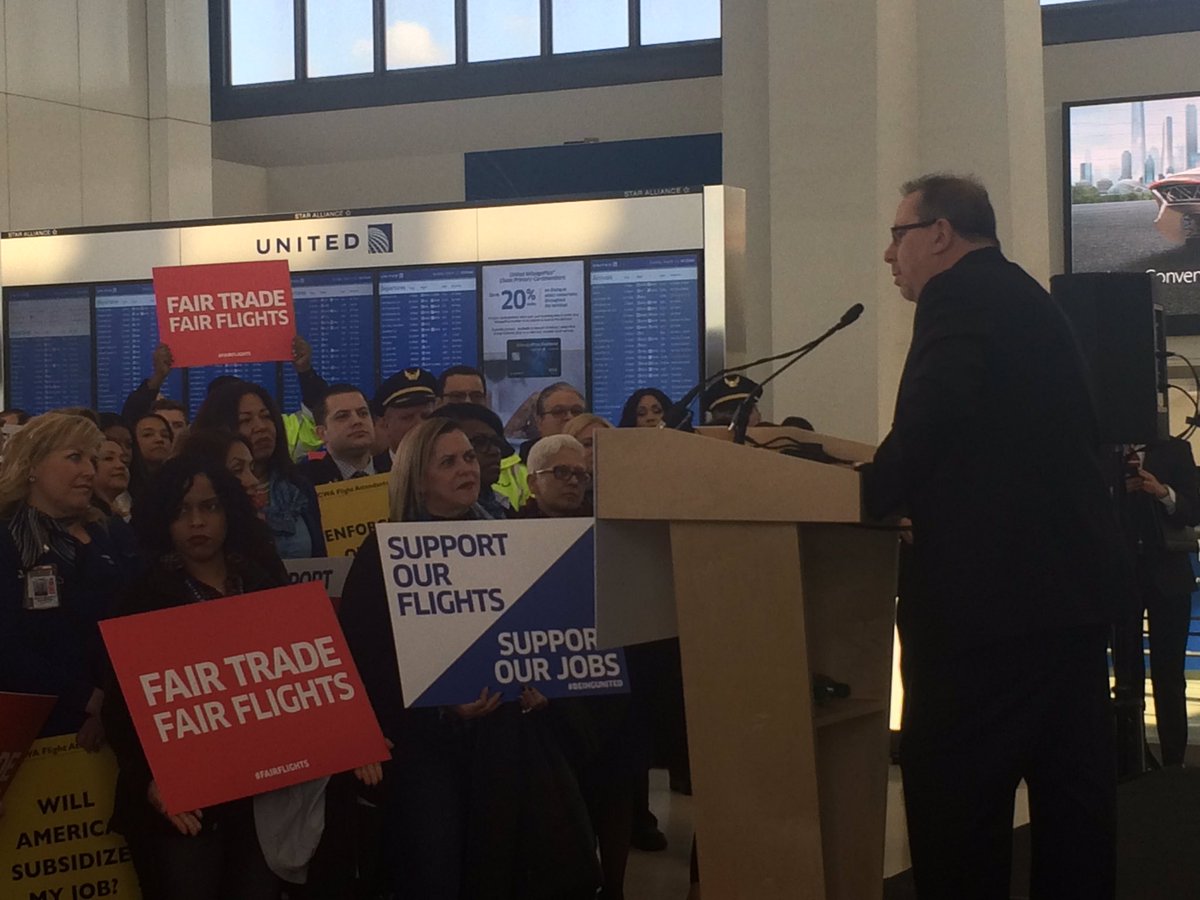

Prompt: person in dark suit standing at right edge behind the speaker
[{"left": 1112, "top": 438, "right": 1200, "bottom": 766}]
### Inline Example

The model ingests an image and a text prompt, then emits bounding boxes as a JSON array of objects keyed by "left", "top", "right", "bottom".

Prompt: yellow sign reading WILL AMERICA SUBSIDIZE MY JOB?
[{"left": 0, "top": 734, "right": 142, "bottom": 900}]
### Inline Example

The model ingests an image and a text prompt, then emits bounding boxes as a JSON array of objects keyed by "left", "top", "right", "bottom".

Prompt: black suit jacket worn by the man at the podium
[{"left": 863, "top": 247, "right": 1133, "bottom": 654}]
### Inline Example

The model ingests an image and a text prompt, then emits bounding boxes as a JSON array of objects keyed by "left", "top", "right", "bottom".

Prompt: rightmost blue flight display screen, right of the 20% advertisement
[{"left": 590, "top": 253, "right": 701, "bottom": 422}]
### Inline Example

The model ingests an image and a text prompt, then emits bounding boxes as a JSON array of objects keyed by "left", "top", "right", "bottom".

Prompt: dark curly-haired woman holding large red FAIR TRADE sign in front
[{"left": 104, "top": 452, "right": 367, "bottom": 900}]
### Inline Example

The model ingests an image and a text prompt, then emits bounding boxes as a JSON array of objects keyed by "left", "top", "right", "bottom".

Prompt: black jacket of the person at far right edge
[{"left": 1121, "top": 438, "right": 1200, "bottom": 596}]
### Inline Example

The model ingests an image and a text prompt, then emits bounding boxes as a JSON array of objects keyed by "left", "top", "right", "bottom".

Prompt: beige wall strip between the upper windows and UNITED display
[{"left": 212, "top": 78, "right": 721, "bottom": 216}]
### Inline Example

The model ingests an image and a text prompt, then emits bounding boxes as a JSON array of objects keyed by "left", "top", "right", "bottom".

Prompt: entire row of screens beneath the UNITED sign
[{"left": 4, "top": 251, "right": 703, "bottom": 427}]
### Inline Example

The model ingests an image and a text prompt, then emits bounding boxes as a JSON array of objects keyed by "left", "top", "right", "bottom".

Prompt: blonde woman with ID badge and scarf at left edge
[{"left": 0, "top": 413, "right": 136, "bottom": 750}]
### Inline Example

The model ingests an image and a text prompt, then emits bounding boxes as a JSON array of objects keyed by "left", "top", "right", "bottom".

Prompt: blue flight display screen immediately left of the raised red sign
[{"left": 96, "top": 281, "right": 184, "bottom": 413}]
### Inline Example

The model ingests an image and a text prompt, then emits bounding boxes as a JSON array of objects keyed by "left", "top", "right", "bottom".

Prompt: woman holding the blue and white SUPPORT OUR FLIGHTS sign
[{"left": 340, "top": 418, "right": 598, "bottom": 900}]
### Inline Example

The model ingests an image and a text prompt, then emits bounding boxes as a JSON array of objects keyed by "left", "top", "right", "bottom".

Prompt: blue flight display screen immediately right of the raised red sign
[{"left": 283, "top": 271, "right": 378, "bottom": 410}]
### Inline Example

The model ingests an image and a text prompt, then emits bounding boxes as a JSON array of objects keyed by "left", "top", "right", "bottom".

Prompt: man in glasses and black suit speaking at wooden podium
[{"left": 863, "top": 175, "right": 1130, "bottom": 900}]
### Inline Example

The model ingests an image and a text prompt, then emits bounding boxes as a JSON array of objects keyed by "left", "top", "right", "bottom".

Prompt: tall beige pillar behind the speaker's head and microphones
[{"left": 724, "top": 0, "right": 1050, "bottom": 440}]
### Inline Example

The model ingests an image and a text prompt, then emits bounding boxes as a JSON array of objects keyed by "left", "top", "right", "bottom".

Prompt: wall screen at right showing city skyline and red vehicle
[{"left": 1063, "top": 96, "right": 1200, "bottom": 334}]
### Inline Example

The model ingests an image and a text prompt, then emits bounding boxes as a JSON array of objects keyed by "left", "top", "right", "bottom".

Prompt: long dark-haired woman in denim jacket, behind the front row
[{"left": 192, "top": 382, "right": 325, "bottom": 559}]
